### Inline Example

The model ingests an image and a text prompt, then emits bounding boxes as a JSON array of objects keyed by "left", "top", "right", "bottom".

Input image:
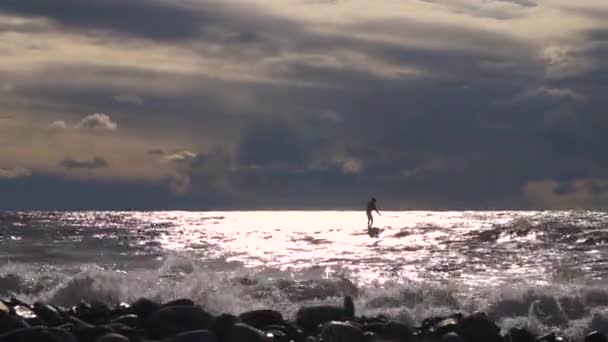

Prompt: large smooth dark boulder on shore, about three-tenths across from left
[{"left": 146, "top": 305, "right": 214, "bottom": 339}]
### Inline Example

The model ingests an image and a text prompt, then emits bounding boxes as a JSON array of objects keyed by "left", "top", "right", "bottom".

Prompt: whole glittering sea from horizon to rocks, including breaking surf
[{"left": 0, "top": 211, "right": 608, "bottom": 337}]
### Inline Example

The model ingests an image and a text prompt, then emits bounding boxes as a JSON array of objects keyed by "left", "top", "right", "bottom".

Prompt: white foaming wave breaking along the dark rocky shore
[{"left": 0, "top": 254, "right": 608, "bottom": 337}]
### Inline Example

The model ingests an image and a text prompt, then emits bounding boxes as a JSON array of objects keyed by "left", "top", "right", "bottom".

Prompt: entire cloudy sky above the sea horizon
[{"left": 0, "top": 0, "right": 608, "bottom": 210}]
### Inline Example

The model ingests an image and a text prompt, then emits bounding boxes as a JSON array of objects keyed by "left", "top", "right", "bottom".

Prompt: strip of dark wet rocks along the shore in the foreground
[{"left": 0, "top": 296, "right": 608, "bottom": 342}]
